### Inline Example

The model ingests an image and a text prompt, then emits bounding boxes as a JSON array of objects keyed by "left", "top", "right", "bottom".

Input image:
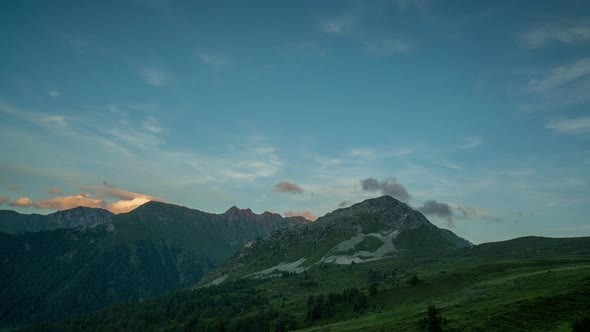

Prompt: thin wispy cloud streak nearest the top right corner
[{"left": 520, "top": 23, "right": 590, "bottom": 49}]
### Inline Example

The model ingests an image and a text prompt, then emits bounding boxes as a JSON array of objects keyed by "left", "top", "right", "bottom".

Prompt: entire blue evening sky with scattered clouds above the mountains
[{"left": 0, "top": 0, "right": 590, "bottom": 243}]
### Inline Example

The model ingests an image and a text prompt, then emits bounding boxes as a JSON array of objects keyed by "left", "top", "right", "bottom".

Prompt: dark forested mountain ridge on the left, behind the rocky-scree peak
[{"left": 0, "top": 202, "right": 307, "bottom": 327}]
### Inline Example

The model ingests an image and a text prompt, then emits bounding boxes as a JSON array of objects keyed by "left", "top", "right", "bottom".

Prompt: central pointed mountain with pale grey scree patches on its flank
[{"left": 210, "top": 196, "right": 472, "bottom": 279}]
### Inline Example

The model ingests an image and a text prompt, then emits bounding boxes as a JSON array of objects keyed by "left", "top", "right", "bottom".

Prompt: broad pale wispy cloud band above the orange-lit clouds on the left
[{"left": 0, "top": 102, "right": 284, "bottom": 192}]
